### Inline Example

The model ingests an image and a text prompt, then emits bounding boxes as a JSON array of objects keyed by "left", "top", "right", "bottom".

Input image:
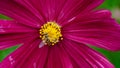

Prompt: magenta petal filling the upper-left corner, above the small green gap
[{"left": 0, "top": 0, "right": 42, "bottom": 28}]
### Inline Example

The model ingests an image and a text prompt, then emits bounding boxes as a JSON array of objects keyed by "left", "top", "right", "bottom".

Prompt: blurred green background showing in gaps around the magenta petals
[{"left": 0, "top": 0, "right": 120, "bottom": 68}]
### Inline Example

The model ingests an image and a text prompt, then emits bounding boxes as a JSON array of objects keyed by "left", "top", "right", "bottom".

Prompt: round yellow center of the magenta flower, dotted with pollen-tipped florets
[{"left": 40, "top": 22, "right": 63, "bottom": 46}]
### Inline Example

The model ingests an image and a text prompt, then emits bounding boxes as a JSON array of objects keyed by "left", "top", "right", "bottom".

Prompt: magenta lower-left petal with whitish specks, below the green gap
[{"left": 1, "top": 40, "right": 48, "bottom": 68}]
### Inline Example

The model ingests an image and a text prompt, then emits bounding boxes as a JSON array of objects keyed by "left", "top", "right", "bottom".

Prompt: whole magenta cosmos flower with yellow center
[{"left": 0, "top": 0, "right": 120, "bottom": 68}]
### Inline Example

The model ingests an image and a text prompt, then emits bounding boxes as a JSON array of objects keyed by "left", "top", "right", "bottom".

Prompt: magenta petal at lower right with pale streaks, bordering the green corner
[{"left": 63, "top": 39, "right": 114, "bottom": 68}]
